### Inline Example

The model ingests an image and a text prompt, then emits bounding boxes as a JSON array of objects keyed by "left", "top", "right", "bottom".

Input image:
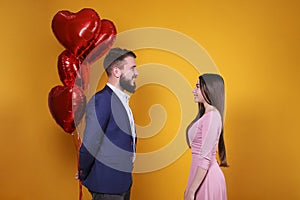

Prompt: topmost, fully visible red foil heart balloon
[{"left": 52, "top": 8, "right": 101, "bottom": 57}]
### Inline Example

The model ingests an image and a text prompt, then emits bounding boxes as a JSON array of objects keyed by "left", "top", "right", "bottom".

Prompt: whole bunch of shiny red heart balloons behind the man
[{"left": 48, "top": 8, "right": 116, "bottom": 133}]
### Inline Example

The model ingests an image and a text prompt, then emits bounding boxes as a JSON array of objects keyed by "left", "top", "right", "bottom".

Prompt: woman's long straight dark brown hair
[{"left": 186, "top": 74, "right": 228, "bottom": 167}]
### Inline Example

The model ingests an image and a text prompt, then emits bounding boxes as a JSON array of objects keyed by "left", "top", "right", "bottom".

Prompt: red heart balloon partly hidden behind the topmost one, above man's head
[{"left": 83, "top": 19, "right": 117, "bottom": 64}]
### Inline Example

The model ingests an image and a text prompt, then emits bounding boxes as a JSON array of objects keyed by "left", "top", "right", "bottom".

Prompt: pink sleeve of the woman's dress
[{"left": 197, "top": 111, "right": 222, "bottom": 170}]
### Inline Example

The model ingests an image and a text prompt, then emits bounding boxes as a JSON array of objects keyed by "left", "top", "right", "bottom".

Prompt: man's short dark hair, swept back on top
[{"left": 103, "top": 48, "right": 136, "bottom": 76}]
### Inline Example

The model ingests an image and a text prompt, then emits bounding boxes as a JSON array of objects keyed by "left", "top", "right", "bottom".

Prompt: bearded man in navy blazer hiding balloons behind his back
[{"left": 78, "top": 48, "right": 138, "bottom": 200}]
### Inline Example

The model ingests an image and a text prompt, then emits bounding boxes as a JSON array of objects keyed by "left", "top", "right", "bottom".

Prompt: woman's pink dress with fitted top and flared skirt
[{"left": 186, "top": 111, "right": 227, "bottom": 200}]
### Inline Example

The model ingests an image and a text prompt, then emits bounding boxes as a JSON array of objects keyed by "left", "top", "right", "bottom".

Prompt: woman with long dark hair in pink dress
[{"left": 184, "top": 74, "right": 228, "bottom": 200}]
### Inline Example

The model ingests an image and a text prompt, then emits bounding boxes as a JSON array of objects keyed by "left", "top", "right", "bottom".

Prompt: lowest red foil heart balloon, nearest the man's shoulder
[{"left": 48, "top": 85, "right": 86, "bottom": 133}]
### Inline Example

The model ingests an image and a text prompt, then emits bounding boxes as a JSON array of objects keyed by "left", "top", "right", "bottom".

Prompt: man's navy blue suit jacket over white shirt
[{"left": 79, "top": 86, "right": 133, "bottom": 194}]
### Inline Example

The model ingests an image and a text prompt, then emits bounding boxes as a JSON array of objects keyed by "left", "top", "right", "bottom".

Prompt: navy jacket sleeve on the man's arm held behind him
[{"left": 78, "top": 95, "right": 110, "bottom": 180}]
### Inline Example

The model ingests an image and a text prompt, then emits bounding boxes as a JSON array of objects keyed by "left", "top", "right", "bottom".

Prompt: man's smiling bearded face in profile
[{"left": 120, "top": 56, "right": 138, "bottom": 93}]
